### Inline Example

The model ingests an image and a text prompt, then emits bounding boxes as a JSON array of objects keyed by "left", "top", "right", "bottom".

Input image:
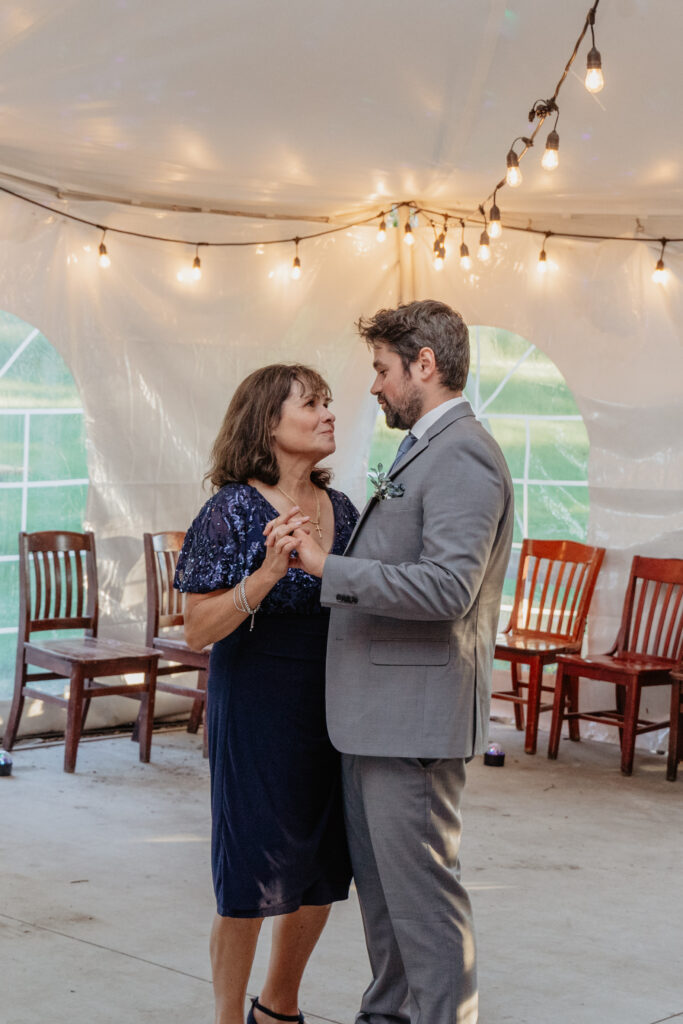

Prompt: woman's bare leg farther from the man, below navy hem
[{"left": 210, "top": 914, "right": 263, "bottom": 1024}]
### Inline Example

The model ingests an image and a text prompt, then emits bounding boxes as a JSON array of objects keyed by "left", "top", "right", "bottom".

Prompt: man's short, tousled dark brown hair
[{"left": 356, "top": 299, "right": 470, "bottom": 391}]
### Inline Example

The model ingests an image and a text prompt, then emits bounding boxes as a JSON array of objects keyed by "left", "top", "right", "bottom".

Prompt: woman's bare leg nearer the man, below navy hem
[{"left": 253, "top": 905, "right": 330, "bottom": 1024}]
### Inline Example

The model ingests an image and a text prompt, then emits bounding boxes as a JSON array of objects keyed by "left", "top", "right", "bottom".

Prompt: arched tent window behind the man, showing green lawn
[{"left": 369, "top": 327, "right": 589, "bottom": 624}]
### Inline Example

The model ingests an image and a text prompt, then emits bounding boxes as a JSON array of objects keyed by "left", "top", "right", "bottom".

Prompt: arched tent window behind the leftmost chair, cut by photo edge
[{"left": 0, "top": 311, "right": 88, "bottom": 700}]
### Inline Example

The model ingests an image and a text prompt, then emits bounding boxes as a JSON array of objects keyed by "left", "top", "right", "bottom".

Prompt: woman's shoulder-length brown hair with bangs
[{"left": 204, "top": 362, "right": 332, "bottom": 490}]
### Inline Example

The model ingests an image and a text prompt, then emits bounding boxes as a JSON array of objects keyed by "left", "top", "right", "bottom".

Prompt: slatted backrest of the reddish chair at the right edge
[{"left": 616, "top": 555, "right": 683, "bottom": 660}]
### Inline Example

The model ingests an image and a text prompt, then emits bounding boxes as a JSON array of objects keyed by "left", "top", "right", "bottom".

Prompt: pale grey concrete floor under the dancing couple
[{"left": 0, "top": 725, "right": 683, "bottom": 1024}]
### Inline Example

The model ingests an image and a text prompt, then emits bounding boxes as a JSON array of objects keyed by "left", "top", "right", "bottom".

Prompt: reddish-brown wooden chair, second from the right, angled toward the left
[{"left": 548, "top": 556, "right": 683, "bottom": 775}]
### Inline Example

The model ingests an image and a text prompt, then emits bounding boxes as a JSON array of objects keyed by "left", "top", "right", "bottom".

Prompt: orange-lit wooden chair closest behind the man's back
[{"left": 492, "top": 540, "right": 605, "bottom": 754}]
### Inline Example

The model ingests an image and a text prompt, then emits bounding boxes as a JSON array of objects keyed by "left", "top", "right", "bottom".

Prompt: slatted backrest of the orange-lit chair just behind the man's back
[{"left": 509, "top": 539, "right": 604, "bottom": 642}]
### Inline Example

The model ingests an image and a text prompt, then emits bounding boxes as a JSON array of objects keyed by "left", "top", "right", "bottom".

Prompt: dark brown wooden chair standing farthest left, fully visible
[{"left": 4, "top": 530, "right": 159, "bottom": 772}]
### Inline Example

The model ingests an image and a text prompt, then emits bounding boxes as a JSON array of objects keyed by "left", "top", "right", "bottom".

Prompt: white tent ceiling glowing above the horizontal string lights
[{"left": 0, "top": 0, "right": 683, "bottom": 226}]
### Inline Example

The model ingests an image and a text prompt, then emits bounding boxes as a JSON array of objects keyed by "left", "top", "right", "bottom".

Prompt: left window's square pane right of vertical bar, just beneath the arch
[{"left": 29, "top": 413, "right": 88, "bottom": 480}]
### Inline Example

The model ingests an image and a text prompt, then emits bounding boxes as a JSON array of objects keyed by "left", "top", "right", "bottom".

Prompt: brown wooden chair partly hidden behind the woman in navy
[{"left": 143, "top": 530, "right": 211, "bottom": 757}]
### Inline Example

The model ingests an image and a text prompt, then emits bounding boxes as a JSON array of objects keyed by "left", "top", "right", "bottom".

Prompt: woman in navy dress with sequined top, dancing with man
[{"left": 175, "top": 365, "right": 357, "bottom": 1024}]
